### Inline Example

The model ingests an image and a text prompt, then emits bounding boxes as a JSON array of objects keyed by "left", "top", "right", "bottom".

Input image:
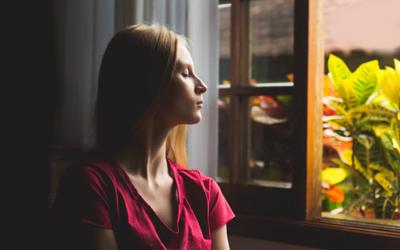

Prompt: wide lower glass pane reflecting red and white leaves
[{"left": 247, "top": 95, "right": 292, "bottom": 188}]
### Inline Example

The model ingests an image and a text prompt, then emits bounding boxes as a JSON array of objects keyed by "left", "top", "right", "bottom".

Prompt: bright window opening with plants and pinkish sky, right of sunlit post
[{"left": 322, "top": 0, "right": 400, "bottom": 225}]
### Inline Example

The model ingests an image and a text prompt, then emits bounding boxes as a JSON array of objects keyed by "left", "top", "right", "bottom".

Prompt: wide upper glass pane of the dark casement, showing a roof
[{"left": 250, "top": 0, "right": 294, "bottom": 84}]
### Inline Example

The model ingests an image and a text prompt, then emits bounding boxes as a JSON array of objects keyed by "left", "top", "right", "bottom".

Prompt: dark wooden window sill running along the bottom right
[{"left": 228, "top": 214, "right": 400, "bottom": 249}]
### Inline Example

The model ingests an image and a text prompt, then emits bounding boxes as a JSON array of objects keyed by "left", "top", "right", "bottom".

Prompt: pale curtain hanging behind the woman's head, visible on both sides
[{"left": 53, "top": 0, "right": 218, "bottom": 177}]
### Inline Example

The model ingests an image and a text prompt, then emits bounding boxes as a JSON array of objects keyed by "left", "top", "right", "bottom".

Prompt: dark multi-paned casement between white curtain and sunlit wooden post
[{"left": 218, "top": 0, "right": 297, "bottom": 217}]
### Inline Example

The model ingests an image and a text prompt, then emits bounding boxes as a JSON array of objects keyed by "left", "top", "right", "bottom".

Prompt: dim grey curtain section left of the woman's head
[{"left": 52, "top": 0, "right": 115, "bottom": 146}]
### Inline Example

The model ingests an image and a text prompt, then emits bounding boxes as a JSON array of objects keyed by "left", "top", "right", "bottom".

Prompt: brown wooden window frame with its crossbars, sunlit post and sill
[{"left": 219, "top": 0, "right": 400, "bottom": 249}]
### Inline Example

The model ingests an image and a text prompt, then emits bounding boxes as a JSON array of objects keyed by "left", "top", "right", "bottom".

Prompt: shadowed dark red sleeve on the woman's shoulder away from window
[{"left": 53, "top": 167, "right": 112, "bottom": 228}]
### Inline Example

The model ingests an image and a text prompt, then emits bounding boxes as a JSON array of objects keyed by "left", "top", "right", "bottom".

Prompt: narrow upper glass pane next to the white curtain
[{"left": 218, "top": 4, "right": 231, "bottom": 85}]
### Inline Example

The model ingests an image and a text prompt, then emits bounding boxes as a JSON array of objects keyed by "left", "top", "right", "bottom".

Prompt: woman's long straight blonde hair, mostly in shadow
[{"left": 95, "top": 24, "right": 189, "bottom": 166}]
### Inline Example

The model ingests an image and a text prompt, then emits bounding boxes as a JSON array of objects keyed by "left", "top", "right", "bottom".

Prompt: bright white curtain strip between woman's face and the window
[{"left": 187, "top": 0, "right": 219, "bottom": 177}]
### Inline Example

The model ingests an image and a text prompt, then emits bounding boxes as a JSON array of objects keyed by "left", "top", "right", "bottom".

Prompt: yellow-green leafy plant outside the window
[{"left": 323, "top": 54, "right": 400, "bottom": 219}]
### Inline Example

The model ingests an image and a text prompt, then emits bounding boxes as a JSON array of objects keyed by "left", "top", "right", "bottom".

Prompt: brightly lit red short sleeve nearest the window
[{"left": 207, "top": 178, "right": 235, "bottom": 232}]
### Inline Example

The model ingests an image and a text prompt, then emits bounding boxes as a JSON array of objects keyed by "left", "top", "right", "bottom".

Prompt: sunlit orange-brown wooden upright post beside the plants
[{"left": 305, "top": 0, "right": 324, "bottom": 219}]
